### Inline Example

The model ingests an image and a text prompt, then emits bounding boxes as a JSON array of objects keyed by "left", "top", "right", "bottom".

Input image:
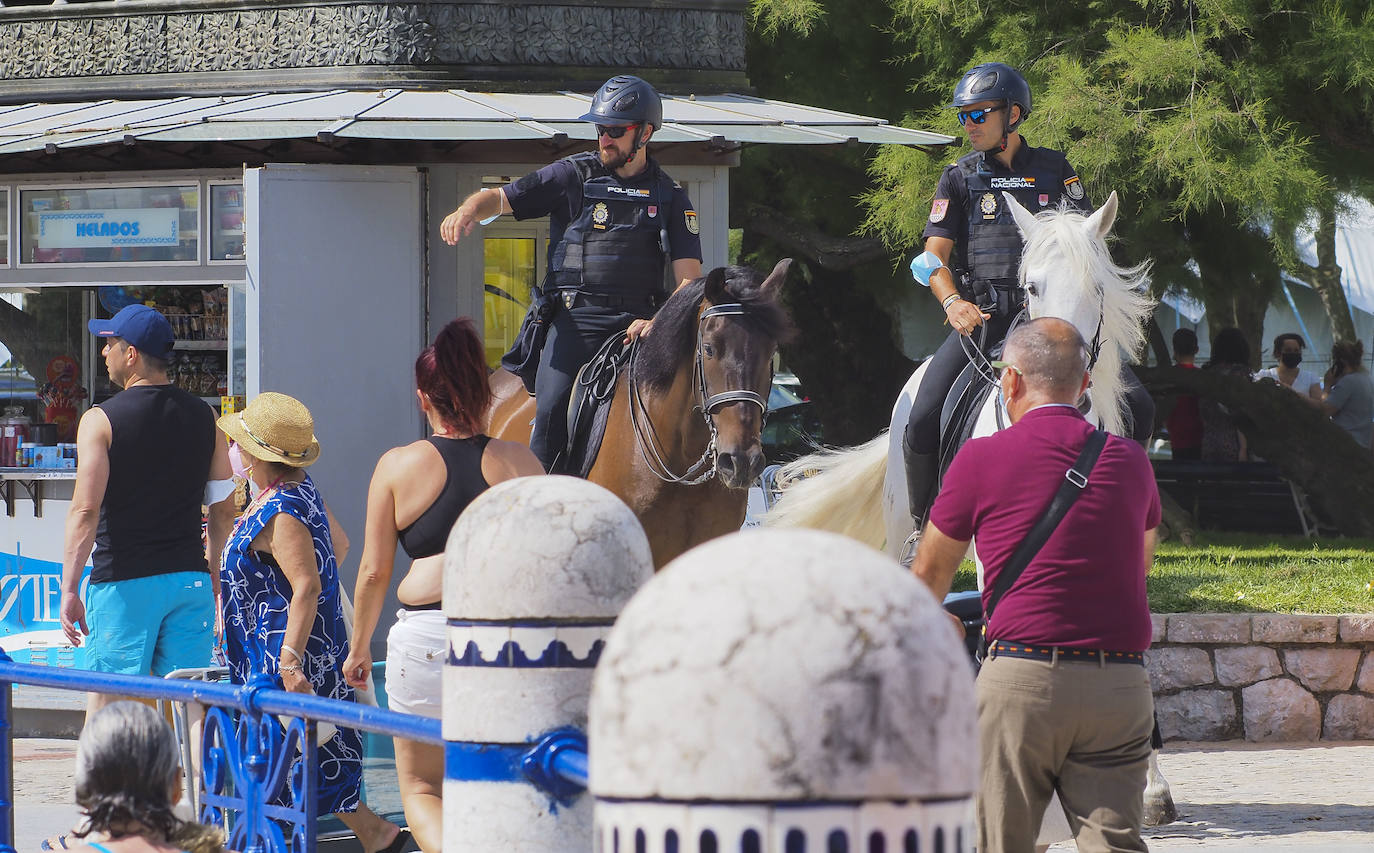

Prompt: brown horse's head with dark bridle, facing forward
[{"left": 695, "top": 258, "right": 791, "bottom": 489}]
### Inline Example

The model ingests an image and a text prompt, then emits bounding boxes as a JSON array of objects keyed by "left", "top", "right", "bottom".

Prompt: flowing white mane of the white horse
[{"left": 1021, "top": 203, "right": 1154, "bottom": 438}]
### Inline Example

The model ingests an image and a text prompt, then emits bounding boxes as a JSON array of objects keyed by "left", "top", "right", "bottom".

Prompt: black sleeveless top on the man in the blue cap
[{"left": 91, "top": 385, "right": 214, "bottom": 584}]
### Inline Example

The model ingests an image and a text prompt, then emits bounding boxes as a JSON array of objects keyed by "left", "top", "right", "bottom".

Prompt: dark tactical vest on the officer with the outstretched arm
[{"left": 548, "top": 152, "right": 673, "bottom": 297}]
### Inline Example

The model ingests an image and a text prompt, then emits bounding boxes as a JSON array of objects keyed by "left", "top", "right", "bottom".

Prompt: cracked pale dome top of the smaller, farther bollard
[{"left": 444, "top": 477, "right": 654, "bottom": 619}]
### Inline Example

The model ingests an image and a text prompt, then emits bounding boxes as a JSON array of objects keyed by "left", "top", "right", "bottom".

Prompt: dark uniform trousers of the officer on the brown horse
[{"left": 529, "top": 302, "right": 653, "bottom": 471}]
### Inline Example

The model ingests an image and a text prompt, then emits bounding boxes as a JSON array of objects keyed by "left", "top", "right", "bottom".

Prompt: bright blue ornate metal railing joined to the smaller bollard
[{"left": 0, "top": 650, "right": 587, "bottom": 853}]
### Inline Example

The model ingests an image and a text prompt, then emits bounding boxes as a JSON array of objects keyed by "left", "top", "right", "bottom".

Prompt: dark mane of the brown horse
[{"left": 635, "top": 266, "right": 794, "bottom": 391}]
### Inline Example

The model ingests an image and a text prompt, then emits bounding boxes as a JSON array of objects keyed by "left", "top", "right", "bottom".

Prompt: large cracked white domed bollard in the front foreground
[{"left": 588, "top": 530, "right": 978, "bottom": 853}]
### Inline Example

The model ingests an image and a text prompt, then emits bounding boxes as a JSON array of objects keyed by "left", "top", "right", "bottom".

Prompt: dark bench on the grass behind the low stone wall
[{"left": 1154, "top": 460, "right": 1318, "bottom": 537}]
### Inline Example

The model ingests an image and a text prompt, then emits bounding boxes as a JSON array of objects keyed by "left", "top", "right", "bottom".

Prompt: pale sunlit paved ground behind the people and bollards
[{"left": 14, "top": 738, "right": 1374, "bottom": 853}]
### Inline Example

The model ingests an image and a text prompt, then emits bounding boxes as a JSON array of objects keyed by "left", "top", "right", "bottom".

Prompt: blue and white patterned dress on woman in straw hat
[{"left": 220, "top": 475, "right": 363, "bottom": 815}]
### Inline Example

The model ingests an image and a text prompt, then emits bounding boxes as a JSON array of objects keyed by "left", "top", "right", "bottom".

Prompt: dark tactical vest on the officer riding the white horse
[{"left": 958, "top": 151, "right": 1063, "bottom": 312}]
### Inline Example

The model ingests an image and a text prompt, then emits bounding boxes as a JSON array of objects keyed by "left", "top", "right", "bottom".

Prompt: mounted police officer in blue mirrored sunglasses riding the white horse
[{"left": 903, "top": 62, "right": 1153, "bottom": 532}]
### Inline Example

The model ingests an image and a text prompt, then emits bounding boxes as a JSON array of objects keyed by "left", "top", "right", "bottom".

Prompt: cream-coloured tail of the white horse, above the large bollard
[{"left": 763, "top": 431, "right": 888, "bottom": 549}]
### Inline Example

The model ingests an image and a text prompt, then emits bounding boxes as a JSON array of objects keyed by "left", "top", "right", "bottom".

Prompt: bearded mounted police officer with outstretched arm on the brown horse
[{"left": 440, "top": 76, "right": 701, "bottom": 468}]
